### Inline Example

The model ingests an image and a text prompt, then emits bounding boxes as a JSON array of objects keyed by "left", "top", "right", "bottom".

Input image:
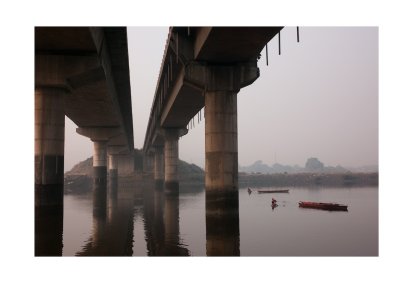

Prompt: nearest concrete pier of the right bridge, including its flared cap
[{"left": 185, "top": 60, "right": 259, "bottom": 211}]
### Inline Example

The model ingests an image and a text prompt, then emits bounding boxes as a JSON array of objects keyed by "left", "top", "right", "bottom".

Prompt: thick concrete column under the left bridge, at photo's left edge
[{"left": 35, "top": 87, "right": 65, "bottom": 209}]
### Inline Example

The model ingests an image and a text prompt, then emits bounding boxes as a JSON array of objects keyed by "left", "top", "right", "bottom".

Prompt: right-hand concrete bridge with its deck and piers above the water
[{"left": 143, "top": 27, "right": 282, "bottom": 216}]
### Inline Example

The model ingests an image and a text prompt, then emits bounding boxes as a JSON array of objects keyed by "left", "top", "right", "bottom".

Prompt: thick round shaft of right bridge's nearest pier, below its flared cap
[{"left": 205, "top": 90, "right": 238, "bottom": 213}]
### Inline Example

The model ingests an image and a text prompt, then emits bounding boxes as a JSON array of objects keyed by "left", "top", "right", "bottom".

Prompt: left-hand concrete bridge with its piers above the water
[{"left": 35, "top": 27, "right": 134, "bottom": 214}]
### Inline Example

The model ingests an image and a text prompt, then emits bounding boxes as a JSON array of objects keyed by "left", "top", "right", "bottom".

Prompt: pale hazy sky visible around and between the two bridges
[{"left": 65, "top": 27, "right": 378, "bottom": 170}]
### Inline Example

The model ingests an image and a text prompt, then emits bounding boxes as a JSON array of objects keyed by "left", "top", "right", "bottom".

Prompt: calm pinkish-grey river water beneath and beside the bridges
[{"left": 62, "top": 187, "right": 378, "bottom": 256}]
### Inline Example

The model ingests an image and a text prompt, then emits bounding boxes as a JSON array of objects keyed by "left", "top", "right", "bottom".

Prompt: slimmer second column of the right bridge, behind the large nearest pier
[{"left": 164, "top": 129, "right": 179, "bottom": 195}]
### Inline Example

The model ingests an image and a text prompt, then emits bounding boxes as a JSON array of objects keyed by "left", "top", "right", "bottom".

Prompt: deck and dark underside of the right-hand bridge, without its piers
[{"left": 148, "top": 27, "right": 282, "bottom": 151}]
